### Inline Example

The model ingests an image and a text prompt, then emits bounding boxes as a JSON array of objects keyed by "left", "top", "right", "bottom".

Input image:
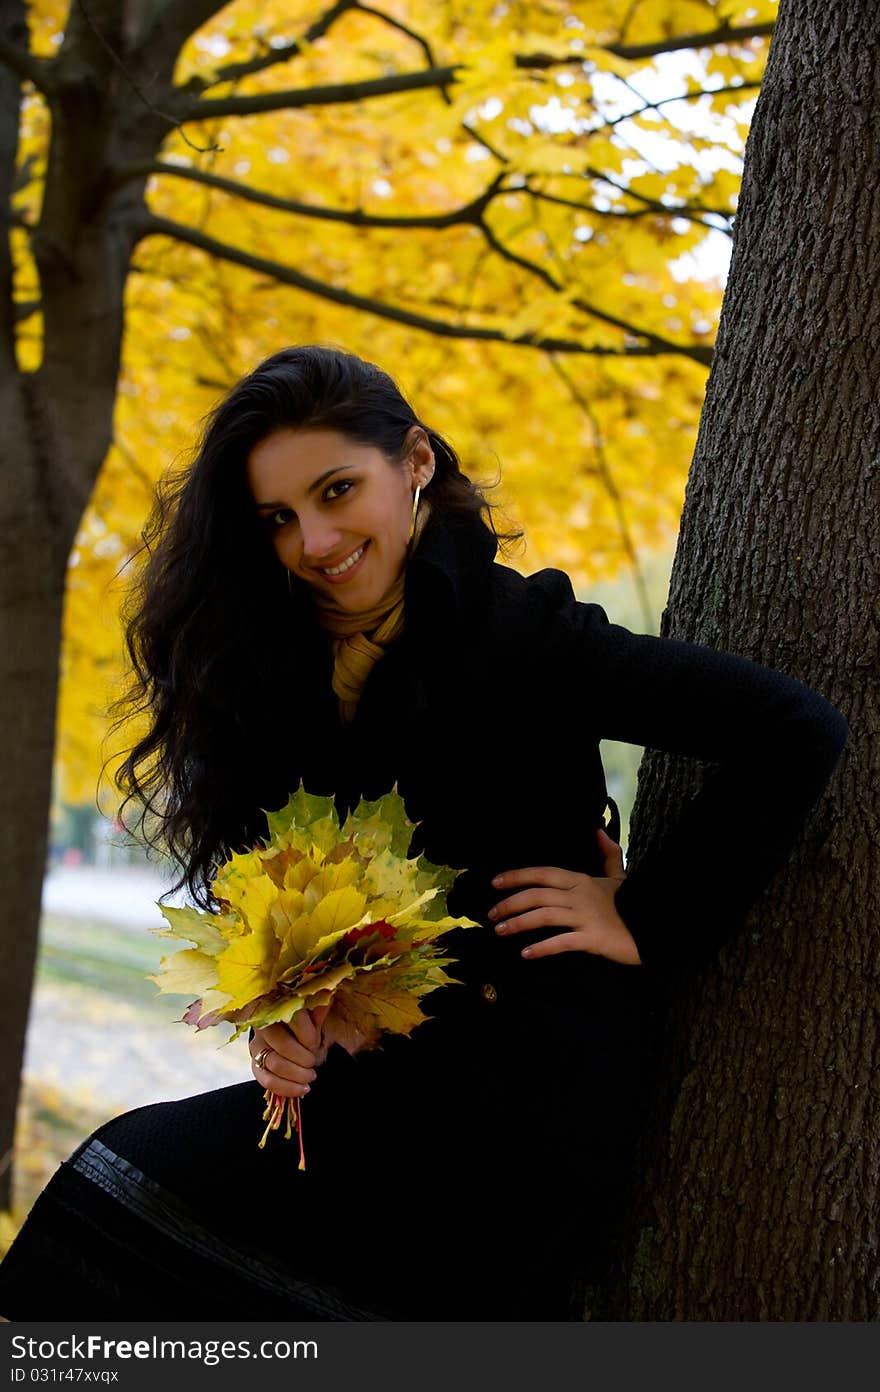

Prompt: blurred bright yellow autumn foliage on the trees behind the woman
[{"left": 11, "top": 0, "right": 776, "bottom": 814}]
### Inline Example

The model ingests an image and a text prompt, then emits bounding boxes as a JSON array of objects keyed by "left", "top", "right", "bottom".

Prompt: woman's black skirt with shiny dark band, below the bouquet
[{"left": 0, "top": 954, "right": 652, "bottom": 1321}]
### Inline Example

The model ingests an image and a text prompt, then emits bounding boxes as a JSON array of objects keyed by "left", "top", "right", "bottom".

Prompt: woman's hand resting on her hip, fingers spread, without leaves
[{"left": 489, "top": 827, "right": 642, "bottom": 966}]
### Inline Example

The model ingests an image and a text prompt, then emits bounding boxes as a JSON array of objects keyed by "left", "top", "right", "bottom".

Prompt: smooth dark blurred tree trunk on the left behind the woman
[{"left": 0, "top": 0, "right": 193, "bottom": 1208}]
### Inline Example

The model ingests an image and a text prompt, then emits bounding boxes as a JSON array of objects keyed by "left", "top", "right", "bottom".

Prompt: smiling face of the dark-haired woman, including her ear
[{"left": 246, "top": 429, "right": 433, "bottom": 612}]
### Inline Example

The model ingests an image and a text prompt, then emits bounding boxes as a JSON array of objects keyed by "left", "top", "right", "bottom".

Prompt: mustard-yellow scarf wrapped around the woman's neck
[{"left": 312, "top": 498, "right": 432, "bottom": 725}]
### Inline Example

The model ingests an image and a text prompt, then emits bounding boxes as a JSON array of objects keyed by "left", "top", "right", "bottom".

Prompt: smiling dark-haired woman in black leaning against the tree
[{"left": 0, "top": 348, "right": 847, "bottom": 1320}]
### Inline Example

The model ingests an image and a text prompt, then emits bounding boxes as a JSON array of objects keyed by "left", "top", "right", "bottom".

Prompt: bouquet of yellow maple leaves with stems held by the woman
[{"left": 150, "top": 784, "right": 478, "bottom": 1169}]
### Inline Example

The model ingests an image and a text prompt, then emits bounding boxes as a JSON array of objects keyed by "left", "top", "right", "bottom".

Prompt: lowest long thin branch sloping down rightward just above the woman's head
[{"left": 134, "top": 214, "right": 684, "bottom": 358}]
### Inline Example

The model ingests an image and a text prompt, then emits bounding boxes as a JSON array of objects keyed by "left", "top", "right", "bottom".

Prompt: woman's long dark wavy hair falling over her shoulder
[{"left": 107, "top": 345, "right": 524, "bottom": 910}]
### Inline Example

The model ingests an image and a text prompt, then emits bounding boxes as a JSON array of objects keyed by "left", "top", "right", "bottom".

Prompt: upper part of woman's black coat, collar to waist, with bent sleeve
[{"left": 293, "top": 503, "right": 848, "bottom": 979}]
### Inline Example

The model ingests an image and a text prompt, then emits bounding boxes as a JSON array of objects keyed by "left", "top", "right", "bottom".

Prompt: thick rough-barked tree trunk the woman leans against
[{"left": 595, "top": 0, "right": 880, "bottom": 1321}]
